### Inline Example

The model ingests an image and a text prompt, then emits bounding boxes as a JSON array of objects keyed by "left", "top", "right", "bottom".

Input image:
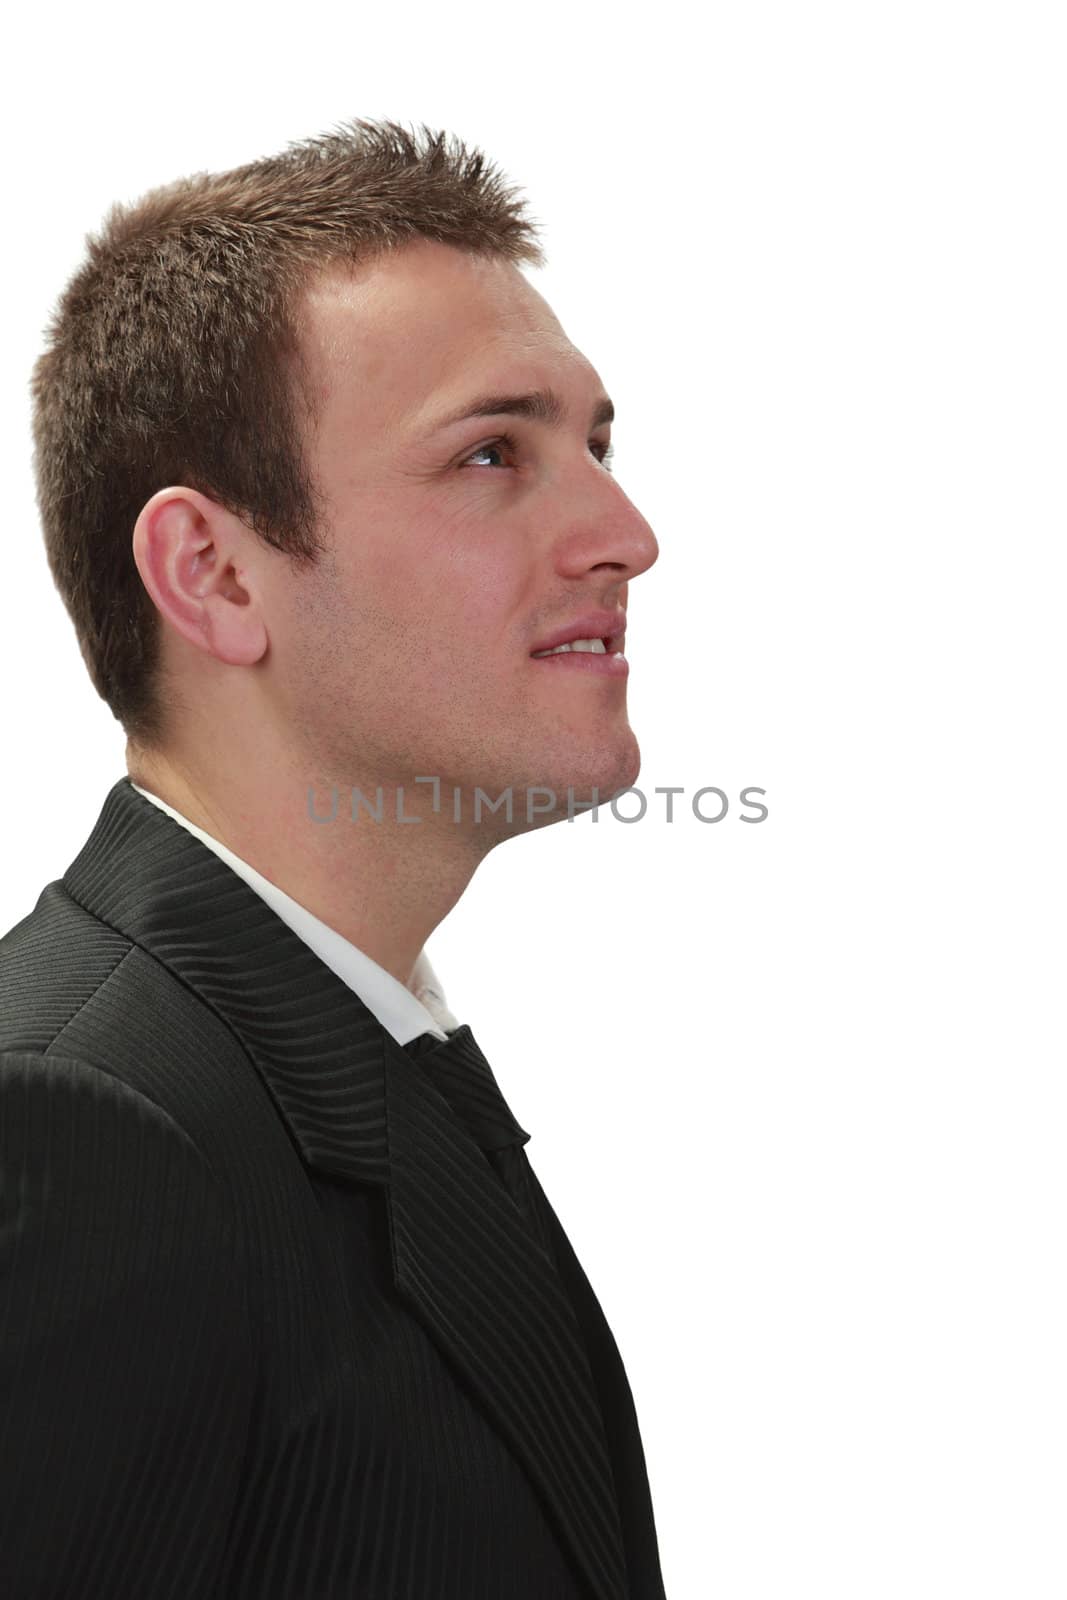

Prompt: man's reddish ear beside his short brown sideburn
[{"left": 133, "top": 488, "right": 267, "bottom": 667}]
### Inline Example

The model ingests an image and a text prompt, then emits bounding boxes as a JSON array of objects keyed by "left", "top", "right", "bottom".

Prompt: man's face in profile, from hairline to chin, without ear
[{"left": 270, "top": 240, "right": 657, "bottom": 830}]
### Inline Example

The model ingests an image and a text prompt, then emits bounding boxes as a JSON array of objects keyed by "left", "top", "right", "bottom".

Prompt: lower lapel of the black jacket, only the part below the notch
[{"left": 386, "top": 1040, "right": 627, "bottom": 1600}]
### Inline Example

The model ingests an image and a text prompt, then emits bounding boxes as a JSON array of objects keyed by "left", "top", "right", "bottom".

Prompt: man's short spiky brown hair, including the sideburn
[{"left": 32, "top": 118, "right": 544, "bottom": 749}]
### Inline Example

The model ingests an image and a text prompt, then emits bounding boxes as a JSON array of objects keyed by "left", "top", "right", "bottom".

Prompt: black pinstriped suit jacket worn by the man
[{"left": 0, "top": 778, "right": 664, "bottom": 1600}]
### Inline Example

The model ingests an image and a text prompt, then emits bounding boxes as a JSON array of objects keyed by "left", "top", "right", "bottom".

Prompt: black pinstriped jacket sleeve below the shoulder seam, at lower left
[{"left": 0, "top": 1050, "right": 256, "bottom": 1595}]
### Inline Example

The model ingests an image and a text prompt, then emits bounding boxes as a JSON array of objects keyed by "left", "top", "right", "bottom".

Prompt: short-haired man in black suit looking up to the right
[{"left": 0, "top": 122, "right": 662, "bottom": 1600}]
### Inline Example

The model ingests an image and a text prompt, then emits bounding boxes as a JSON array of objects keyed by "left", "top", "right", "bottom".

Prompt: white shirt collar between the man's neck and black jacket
[{"left": 130, "top": 779, "right": 459, "bottom": 1045}]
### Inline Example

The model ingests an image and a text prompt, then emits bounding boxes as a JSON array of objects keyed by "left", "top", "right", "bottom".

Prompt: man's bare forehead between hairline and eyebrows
[{"left": 298, "top": 240, "right": 598, "bottom": 429}]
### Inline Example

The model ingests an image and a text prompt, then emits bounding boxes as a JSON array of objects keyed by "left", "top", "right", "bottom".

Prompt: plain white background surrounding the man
[{"left": 0, "top": 0, "right": 1067, "bottom": 1600}]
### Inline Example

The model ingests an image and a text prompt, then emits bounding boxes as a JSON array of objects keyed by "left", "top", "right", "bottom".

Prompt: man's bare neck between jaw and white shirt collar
[{"left": 126, "top": 746, "right": 490, "bottom": 984}]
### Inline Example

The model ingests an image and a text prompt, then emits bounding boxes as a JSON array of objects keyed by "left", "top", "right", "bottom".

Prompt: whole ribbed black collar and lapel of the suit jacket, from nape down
[{"left": 62, "top": 778, "right": 627, "bottom": 1600}]
